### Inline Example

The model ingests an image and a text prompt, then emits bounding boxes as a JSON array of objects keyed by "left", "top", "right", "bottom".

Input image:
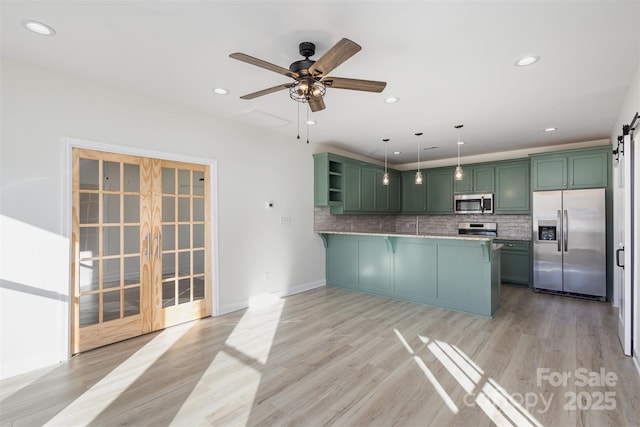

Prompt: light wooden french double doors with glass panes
[{"left": 71, "top": 148, "right": 212, "bottom": 354}]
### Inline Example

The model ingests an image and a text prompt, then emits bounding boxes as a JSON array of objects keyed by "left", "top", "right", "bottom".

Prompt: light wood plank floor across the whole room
[{"left": 0, "top": 287, "right": 640, "bottom": 427}]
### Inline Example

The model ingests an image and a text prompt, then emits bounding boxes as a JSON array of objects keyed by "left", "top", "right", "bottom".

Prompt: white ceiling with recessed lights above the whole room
[{"left": 0, "top": 0, "right": 640, "bottom": 163}]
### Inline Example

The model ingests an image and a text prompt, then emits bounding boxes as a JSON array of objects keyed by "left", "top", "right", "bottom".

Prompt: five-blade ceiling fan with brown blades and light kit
[{"left": 229, "top": 38, "right": 387, "bottom": 112}]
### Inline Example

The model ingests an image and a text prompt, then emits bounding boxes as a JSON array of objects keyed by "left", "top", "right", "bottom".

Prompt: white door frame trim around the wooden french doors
[{"left": 61, "top": 137, "right": 220, "bottom": 359}]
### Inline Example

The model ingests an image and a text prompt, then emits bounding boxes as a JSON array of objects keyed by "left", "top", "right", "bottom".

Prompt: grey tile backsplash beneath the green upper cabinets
[{"left": 314, "top": 207, "right": 531, "bottom": 240}]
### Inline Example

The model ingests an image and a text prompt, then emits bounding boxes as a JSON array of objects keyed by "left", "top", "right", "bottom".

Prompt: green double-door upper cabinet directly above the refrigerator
[{"left": 531, "top": 145, "right": 611, "bottom": 191}]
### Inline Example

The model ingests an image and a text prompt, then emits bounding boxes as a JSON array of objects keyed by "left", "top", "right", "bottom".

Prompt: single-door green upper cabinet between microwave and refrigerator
[{"left": 494, "top": 160, "right": 531, "bottom": 214}]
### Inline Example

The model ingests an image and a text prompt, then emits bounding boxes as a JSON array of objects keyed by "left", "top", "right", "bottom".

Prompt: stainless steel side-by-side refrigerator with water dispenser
[{"left": 533, "top": 188, "right": 607, "bottom": 301}]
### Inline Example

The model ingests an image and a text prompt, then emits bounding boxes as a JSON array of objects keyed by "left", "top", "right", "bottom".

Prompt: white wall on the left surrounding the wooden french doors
[{"left": 0, "top": 58, "right": 325, "bottom": 378}]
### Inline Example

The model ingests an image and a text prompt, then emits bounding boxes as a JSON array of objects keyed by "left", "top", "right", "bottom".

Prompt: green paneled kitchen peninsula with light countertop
[{"left": 318, "top": 231, "right": 500, "bottom": 317}]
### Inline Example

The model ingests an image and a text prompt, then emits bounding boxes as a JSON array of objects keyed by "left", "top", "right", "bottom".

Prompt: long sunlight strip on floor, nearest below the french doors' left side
[{"left": 45, "top": 322, "right": 196, "bottom": 426}]
